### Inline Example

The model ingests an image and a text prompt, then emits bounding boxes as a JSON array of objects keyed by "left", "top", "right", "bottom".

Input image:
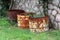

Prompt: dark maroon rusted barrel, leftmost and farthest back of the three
[{"left": 7, "top": 10, "right": 25, "bottom": 22}]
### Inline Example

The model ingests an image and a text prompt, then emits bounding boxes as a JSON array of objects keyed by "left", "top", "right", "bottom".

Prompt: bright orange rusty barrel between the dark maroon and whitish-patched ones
[{"left": 17, "top": 14, "right": 29, "bottom": 28}]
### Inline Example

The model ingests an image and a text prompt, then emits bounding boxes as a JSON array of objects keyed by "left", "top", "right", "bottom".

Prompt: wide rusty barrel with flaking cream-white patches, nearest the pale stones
[{"left": 29, "top": 17, "right": 49, "bottom": 32}]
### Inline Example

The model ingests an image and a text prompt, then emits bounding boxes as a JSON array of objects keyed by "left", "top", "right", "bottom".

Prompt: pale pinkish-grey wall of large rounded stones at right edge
[{"left": 48, "top": 0, "right": 60, "bottom": 29}]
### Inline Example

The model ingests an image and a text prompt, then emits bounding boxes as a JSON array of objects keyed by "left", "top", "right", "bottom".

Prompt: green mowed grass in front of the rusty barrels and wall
[{"left": 0, "top": 18, "right": 60, "bottom": 40}]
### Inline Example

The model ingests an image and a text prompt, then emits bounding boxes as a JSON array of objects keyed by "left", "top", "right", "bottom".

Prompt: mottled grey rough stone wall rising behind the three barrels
[{"left": 10, "top": 0, "right": 45, "bottom": 18}]
